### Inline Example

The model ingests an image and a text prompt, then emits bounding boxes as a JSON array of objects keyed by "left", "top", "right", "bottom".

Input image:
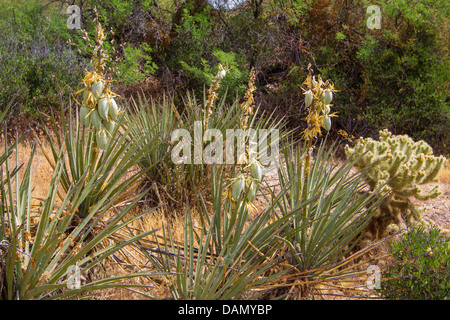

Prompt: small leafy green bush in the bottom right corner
[{"left": 381, "top": 227, "right": 450, "bottom": 300}]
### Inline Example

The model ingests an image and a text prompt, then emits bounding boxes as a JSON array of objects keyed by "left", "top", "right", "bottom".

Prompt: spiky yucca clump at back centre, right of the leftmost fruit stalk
[{"left": 125, "top": 71, "right": 287, "bottom": 209}]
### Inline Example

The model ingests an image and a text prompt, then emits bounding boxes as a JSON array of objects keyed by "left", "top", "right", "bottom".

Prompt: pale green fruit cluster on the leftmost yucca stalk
[{"left": 80, "top": 80, "right": 119, "bottom": 149}]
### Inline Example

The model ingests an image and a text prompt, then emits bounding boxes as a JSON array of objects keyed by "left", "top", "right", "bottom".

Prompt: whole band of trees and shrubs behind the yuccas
[{"left": 0, "top": 0, "right": 450, "bottom": 153}]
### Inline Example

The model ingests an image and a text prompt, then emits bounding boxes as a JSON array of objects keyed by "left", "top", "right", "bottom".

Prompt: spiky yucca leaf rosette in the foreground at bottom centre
[{"left": 138, "top": 166, "right": 316, "bottom": 300}]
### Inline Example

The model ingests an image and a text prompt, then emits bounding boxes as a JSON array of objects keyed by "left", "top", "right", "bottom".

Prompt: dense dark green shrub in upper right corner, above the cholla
[{"left": 357, "top": 1, "right": 450, "bottom": 151}]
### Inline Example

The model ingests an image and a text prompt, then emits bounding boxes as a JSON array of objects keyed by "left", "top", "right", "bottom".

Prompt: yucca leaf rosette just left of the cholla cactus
[{"left": 277, "top": 141, "right": 388, "bottom": 295}]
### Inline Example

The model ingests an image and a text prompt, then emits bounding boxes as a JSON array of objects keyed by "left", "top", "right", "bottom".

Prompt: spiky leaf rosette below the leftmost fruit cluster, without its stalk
[{"left": 42, "top": 100, "right": 155, "bottom": 218}]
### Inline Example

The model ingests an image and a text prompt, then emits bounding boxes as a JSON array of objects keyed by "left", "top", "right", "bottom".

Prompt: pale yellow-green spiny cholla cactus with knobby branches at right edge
[{"left": 345, "top": 130, "right": 446, "bottom": 238}]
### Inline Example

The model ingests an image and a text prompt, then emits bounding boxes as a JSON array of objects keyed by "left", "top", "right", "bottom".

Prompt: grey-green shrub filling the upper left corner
[{"left": 0, "top": 1, "right": 85, "bottom": 115}]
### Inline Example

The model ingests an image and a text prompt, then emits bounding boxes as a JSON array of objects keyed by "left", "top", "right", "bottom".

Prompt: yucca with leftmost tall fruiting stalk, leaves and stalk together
[{"left": 39, "top": 17, "right": 156, "bottom": 218}]
